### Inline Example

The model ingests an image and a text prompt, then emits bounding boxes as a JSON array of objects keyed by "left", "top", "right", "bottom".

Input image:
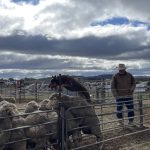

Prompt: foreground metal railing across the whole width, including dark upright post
[{"left": 0, "top": 78, "right": 150, "bottom": 150}]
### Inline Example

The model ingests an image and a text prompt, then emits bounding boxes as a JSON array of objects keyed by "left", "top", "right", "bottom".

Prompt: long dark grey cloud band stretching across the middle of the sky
[{"left": 0, "top": 35, "right": 150, "bottom": 59}]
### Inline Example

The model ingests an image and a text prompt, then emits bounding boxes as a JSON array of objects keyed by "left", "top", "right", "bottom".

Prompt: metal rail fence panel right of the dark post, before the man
[{"left": 61, "top": 100, "right": 150, "bottom": 149}]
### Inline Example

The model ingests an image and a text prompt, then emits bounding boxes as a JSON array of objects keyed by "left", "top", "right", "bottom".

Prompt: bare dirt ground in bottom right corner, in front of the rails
[{"left": 78, "top": 125, "right": 150, "bottom": 150}]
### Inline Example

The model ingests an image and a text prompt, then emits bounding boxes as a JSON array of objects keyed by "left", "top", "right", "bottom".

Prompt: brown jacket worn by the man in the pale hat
[{"left": 111, "top": 72, "right": 136, "bottom": 98}]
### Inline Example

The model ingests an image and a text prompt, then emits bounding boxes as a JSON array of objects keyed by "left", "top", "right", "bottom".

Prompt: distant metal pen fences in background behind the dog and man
[{"left": 0, "top": 80, "right": 150, "bottom": 103}]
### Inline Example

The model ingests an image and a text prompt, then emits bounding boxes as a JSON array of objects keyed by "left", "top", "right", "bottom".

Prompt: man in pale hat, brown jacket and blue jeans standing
[{"left": 111, "top": 64, "right": 136, "bottom": 126}]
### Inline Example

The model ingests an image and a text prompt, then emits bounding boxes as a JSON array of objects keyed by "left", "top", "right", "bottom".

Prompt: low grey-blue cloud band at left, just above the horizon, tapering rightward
[{"left": 0, "top": 54, "right": 89, "bottom": 70}]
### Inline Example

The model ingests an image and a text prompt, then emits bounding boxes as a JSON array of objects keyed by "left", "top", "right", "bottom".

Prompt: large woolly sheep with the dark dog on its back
[{"left": 50, "top": 93, "right": 102, "bottom": 149}]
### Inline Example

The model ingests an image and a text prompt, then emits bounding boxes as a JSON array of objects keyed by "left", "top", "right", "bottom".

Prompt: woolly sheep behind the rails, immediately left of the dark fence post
[{"left": 25, "top": 111, "right": 57, "bottom": 150}]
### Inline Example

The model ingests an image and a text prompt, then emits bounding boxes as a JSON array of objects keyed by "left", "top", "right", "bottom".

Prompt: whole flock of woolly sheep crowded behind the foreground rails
[{"left": 0, "top": 93, "right": 102, "bottom": 150}]
